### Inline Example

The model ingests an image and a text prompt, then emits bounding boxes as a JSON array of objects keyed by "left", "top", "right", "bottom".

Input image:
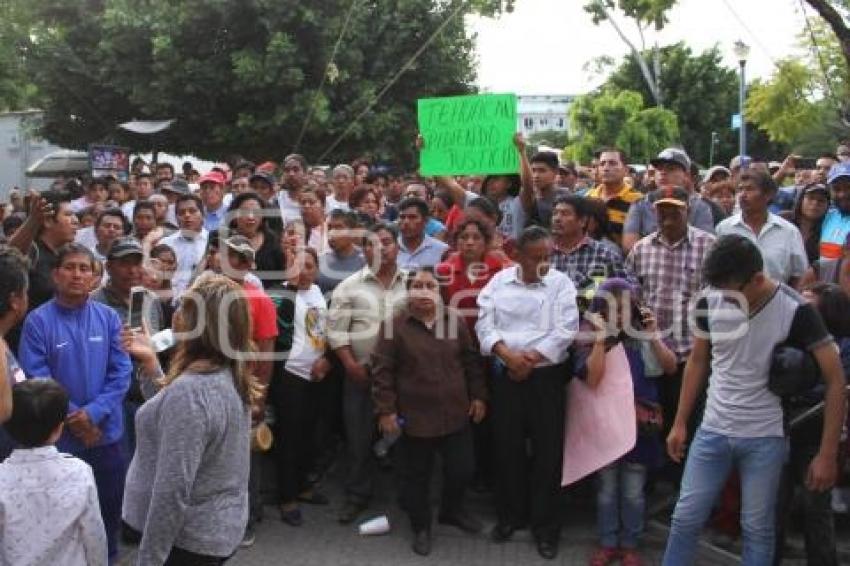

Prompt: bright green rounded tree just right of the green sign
[{"left": 564, "top": 90, "right": 679, "bottom": 163}]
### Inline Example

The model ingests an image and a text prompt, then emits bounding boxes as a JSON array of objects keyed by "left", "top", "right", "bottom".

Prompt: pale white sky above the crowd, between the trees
[{"left": 468, "top": 0, "right": 812, "bottom": 94}]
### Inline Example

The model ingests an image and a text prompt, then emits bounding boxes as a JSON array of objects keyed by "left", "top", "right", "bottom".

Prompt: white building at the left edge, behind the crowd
[{"left": 0, "top": 110, "right": 61, "bottom": 202}]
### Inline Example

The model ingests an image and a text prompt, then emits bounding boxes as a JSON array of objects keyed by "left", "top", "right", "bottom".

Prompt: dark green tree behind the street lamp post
[{"left": 603, "top": 43, "right": 738, "bottom": 163}]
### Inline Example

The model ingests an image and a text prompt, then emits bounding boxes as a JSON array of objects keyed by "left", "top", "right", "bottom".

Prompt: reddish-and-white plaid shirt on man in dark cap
[{"left": 626, "top": 226, "right": 715, "bottom": 361}]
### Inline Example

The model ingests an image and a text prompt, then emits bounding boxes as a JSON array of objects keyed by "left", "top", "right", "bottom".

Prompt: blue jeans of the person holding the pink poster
[{"left": 596, "top": 460, "right": 646, "bottom": 549}]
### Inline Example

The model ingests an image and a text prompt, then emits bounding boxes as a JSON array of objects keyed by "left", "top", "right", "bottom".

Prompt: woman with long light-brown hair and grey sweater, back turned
[{"left": 123, "top": 274, "right": 256, "bottom": 566}]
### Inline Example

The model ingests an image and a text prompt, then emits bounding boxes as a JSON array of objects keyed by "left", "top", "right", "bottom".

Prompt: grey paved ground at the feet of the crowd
[{"left": 122, "top": 458, "right": 748, "bottom": 566}]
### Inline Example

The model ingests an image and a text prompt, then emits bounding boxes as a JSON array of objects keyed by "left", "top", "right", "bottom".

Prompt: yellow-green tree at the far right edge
[{"left": 747, "top": 21, "right": 850, "bottom": 155}]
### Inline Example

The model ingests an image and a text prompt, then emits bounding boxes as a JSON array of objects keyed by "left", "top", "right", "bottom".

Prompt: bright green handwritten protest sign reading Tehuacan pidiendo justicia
[{"left": 418, "top": 94, "right": 519, "bottom": 176}]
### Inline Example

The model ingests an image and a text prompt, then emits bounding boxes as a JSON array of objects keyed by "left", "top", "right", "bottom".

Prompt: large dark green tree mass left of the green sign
[{"left": 13, "top": 0, "right": 511, "bottom": 163}]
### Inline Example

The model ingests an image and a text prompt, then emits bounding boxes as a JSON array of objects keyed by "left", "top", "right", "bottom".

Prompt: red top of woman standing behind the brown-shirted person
[{"left": 435, "top": 252, "right": 513, "bottom": 338}]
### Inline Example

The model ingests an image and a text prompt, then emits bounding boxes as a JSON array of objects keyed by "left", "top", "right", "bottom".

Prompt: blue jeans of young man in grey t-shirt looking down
[{"left": 663, "top": 428, "right": 787, "bottom": 566}]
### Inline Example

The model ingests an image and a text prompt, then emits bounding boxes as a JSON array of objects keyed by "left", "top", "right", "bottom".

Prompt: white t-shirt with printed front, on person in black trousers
[{"left": 284, "top": 285, "right": 328, "bottom": 380}]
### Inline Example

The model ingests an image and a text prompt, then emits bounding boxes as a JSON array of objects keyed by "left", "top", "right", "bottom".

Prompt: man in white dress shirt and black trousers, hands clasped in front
[{"left": 475, "top": 226, "right": 579, "bottom": 559}]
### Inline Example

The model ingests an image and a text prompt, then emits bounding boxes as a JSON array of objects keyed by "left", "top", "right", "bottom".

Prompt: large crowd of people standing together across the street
[{"left": 0, "top": 136, "right": 850, "bottom": 566}]
